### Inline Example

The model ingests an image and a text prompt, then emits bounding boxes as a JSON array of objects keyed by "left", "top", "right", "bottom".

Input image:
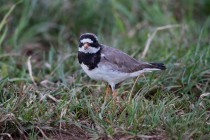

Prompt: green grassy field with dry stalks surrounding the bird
[{"left": 0, "top": 0, "right": 210, "bottom": 140}]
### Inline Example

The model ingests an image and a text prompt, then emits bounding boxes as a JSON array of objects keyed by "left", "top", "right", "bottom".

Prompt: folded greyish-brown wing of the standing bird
[{"left": 101, "top": 45, "right": 151, "bottom": 73}]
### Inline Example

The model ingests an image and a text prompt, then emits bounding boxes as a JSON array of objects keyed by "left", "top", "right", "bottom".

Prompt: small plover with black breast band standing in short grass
[{"left": 78, "top": 33, "right": 166, "bottom": 101}]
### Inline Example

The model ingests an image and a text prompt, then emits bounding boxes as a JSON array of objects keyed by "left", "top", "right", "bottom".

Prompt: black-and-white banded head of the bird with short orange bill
[{"left": 79, "top": 33, "right": 100, "bottom": 53}]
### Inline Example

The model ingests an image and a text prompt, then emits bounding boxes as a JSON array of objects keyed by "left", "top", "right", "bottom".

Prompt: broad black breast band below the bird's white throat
[{"left": 78, "top": 49, "right": 101, "bottom": 70}]
